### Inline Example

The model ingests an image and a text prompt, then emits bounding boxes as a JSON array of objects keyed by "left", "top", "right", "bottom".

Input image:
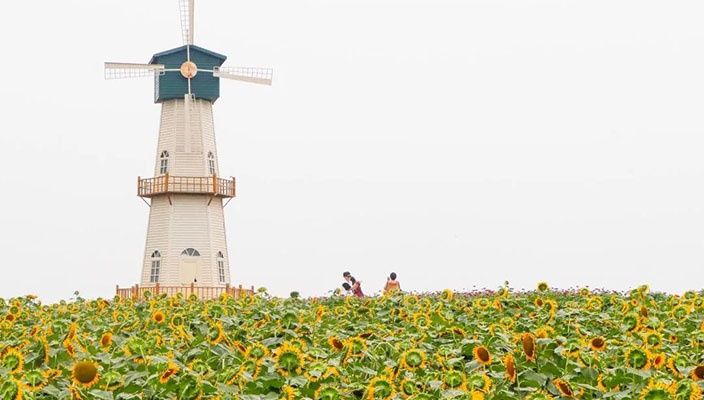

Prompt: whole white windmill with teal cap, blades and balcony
[{"left": 105, "top": 0, "right": 272, "bottom": 291}]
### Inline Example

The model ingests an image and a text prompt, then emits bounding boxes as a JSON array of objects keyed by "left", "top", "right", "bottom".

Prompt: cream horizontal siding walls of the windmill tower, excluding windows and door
[{"left": 141, "top": 99, "right": 230, "bottom": 286}]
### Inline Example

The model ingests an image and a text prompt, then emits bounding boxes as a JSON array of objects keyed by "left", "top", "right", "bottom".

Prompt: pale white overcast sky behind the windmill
[{"left": 0, "top": 0, "right": 704, "bottom": 302}]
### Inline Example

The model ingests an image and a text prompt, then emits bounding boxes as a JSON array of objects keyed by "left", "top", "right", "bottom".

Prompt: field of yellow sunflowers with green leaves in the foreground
[{"left": 0, "top": 282, "right": 704, "bottom": 400}]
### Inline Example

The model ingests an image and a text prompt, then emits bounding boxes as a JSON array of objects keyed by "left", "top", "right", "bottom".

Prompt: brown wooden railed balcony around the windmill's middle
[{"left": 137, "top": 174, "right": 235, "bottom": 197}]
